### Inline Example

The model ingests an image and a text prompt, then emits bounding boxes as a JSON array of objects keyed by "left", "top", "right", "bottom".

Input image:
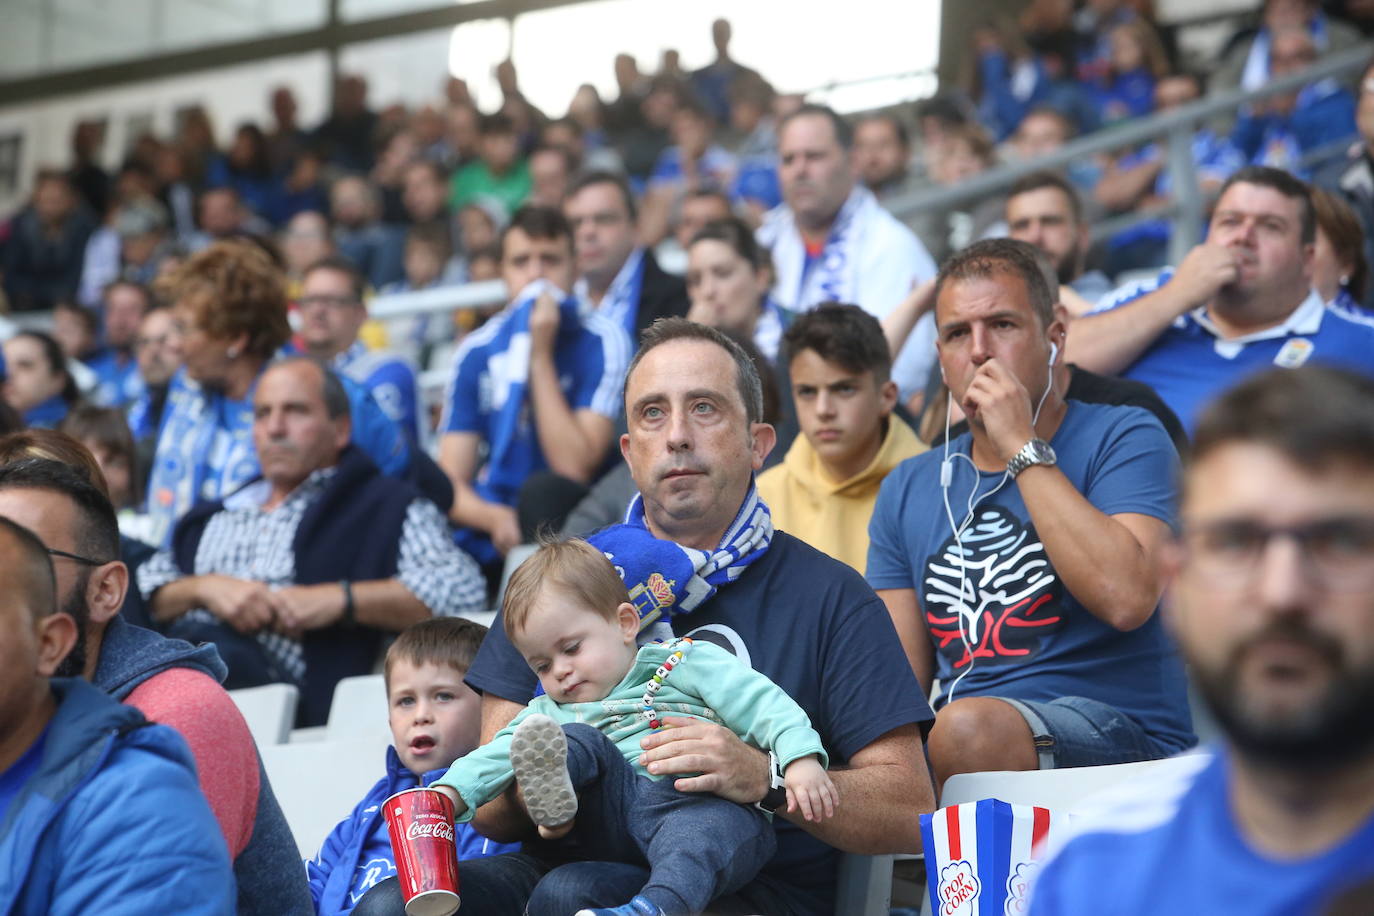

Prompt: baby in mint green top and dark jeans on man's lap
[{"left": 433, "top": 541, "right": 838, "bottom": 916}]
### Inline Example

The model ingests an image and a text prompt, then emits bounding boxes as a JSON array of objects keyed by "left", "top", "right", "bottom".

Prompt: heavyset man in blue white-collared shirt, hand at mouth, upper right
[{"left": 1068, "top": 166, "right": 1374, "bottom": 430}]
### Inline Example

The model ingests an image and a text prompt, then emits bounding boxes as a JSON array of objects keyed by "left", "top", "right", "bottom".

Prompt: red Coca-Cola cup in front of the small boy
[{"left": 383, "top": 788, "right": 459, "bottom": 916}]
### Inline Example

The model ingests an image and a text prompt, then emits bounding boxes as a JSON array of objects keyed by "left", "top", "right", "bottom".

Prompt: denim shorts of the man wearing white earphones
[{"left": 998, "top": 696, "right": 1173, "bottom": 769}]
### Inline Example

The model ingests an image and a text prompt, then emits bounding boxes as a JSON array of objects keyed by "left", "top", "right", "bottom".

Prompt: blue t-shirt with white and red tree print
[{"left": 867, "top": 401, "right": 1194, "bottom": 750}]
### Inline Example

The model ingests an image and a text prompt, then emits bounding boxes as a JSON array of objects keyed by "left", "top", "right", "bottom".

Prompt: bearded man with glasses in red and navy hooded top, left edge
[{"left": 0, "top": 455, "right": 312, "bottom": 916}]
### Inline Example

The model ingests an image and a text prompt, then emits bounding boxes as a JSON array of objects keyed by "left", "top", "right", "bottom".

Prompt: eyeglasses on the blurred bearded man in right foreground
[{"left": 1183, "top": 515, "right": 1374, "bottom": 592}]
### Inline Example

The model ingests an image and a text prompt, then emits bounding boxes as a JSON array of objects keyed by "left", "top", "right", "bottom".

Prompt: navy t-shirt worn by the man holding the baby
[{"left": 467, "top": 531, "right": 934, "bottom": 913}]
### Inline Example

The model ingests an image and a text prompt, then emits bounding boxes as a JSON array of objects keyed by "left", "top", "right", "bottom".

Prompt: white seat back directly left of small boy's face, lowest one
[{"left": 261, "top": 739, "right": 385, "bottom": 858}]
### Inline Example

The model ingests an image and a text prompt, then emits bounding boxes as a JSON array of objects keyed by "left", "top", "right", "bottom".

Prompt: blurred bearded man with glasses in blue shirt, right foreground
[{"left": 1031, "top": 367, "right": 1374, "bottom": 916}]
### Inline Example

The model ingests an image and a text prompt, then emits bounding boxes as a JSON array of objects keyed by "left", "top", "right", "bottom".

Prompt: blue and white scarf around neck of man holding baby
[{"left": 587, "top": 483, "right": 774, "bottom": 645}]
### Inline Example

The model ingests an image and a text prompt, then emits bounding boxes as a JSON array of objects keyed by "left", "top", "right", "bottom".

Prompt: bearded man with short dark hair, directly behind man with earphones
[{"left": 1006, "top": 172, "right": 1112, "bottom": 314}]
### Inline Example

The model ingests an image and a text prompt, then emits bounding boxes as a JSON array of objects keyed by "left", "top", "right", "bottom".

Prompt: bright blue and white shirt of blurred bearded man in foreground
[{"left": 1031, "top": 753, "right": 1374, "bottom": 916}]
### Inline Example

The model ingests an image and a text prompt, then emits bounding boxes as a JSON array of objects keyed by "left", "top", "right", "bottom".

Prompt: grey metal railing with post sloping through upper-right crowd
[{"left": 885, "top": 43, "right": 1374, "bottom": 262}]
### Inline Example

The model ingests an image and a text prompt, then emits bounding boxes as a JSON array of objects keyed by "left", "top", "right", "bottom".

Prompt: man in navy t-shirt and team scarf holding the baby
[{"left": 370, "top": 319, "right": 934, "bottom": 916}]
